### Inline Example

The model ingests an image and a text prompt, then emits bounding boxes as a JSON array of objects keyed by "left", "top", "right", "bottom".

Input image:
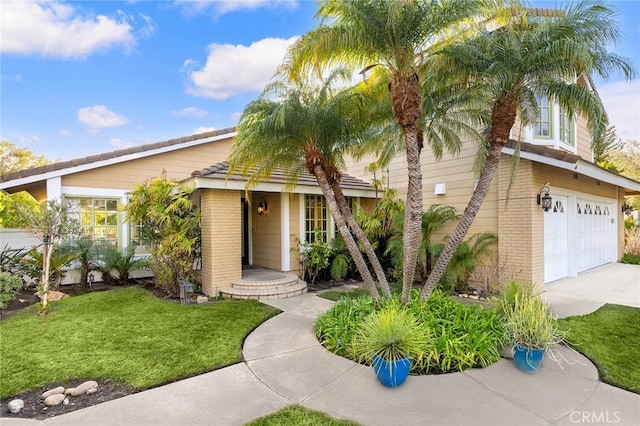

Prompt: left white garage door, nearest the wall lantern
[{"left": 544, "top": 196, "right": 569, "bottom": 283}]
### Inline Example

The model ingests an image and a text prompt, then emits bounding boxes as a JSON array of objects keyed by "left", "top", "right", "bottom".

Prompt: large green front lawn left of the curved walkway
[{"left": 0, "top": 287, "right": 278, "bottom": 398}]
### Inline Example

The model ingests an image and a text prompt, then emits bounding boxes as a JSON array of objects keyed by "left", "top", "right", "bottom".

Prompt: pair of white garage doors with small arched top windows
[{"left": 544, "top": 194, "right": 617, "bottom": 284}]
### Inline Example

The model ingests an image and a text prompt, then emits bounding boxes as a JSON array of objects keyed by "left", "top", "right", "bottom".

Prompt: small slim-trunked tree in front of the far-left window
[{"left": 18, "top": 200, "right": 82, "bottom": 315}]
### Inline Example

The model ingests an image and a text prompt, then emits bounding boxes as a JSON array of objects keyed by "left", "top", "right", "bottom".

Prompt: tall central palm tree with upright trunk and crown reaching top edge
[{"left": 291, "top": 0, "right": 496, "bottom": 303}]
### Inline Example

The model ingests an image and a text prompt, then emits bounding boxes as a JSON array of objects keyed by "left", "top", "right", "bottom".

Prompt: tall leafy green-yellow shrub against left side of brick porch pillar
[{"left": 127, "top": 173, "right": 201, "bottom": 296}]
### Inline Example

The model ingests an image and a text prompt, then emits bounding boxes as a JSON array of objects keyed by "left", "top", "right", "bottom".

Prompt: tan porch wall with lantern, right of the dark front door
[{"left": 251, "top": 192, "right": 282, "bottom": 271}]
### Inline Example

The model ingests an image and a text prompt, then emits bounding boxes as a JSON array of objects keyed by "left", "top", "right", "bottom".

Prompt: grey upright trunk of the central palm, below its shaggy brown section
[{"left": 402, "top": 124, "right": 423, "bottom": 304}]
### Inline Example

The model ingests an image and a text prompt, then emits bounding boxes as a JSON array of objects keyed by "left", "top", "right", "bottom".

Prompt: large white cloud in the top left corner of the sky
[{"left": 0, "top": 0, "right": 148, "bottom": 59}]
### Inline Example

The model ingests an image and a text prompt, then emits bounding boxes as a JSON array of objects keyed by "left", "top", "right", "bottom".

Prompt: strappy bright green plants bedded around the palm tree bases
[{"left": 316, "top": 292, "right": 506, "bottom": 374}]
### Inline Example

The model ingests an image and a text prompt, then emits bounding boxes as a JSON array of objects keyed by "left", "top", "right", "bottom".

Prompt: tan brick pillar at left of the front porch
[{"left": 201, "top": 189, "right": 242, "bottom": 296}]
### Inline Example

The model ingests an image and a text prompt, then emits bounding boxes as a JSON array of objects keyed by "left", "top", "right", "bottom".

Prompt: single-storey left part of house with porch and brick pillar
[{"left": 0, "top": 128, "right": 375, "bottom": 296}]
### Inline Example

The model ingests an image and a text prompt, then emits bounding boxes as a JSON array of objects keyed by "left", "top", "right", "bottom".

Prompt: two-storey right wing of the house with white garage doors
[{"left": 348, "top": 78, "right": 640, "bottom": 285}]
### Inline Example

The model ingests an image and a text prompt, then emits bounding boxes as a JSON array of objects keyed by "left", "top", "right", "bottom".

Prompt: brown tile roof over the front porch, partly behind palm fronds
[{"left": 191, "top": 161, "right": 373, "bottom": 190}]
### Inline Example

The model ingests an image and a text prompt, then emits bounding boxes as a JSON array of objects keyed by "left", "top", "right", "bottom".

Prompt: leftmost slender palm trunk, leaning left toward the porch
[{"left": 313, "top": 164, "right": 380, "bottom": 300}]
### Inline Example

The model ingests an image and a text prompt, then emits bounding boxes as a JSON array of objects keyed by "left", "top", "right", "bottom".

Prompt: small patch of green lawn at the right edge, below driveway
[{"left": 559, "top": 304, "right": 640, "bottom": 393}]
